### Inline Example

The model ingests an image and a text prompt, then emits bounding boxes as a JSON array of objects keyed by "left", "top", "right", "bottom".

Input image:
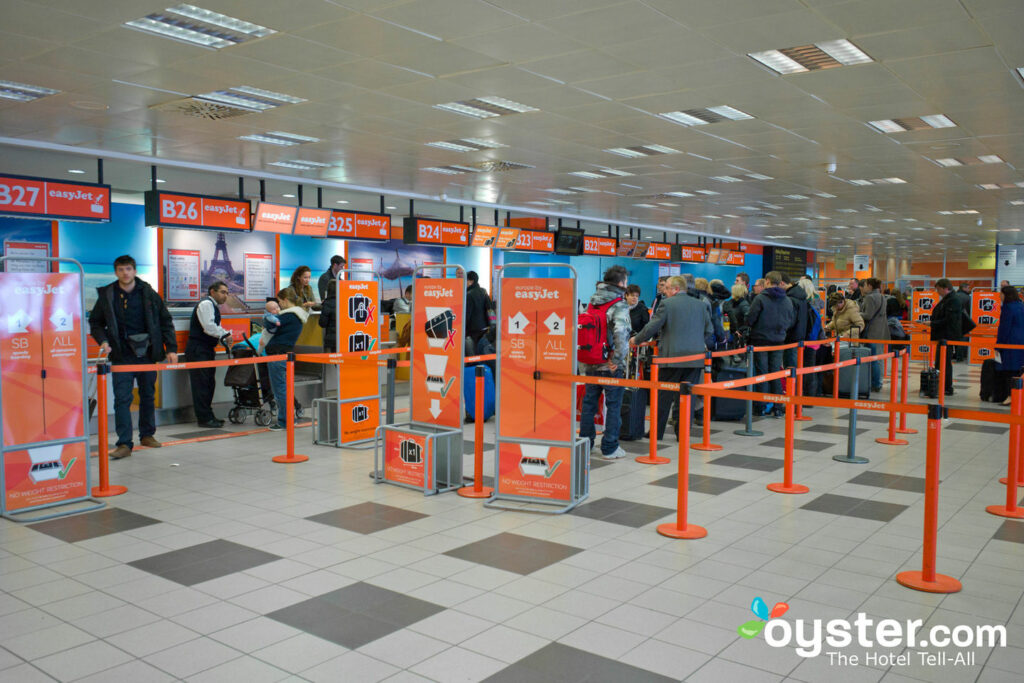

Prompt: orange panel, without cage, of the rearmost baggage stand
[{"left": 337, "top": 280, "right": 381, "bottom": 443}]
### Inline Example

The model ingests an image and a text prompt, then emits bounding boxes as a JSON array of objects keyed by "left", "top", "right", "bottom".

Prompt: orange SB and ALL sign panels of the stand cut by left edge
[{"left": 0, "top": 272, "right": 88, "bottom": 511}]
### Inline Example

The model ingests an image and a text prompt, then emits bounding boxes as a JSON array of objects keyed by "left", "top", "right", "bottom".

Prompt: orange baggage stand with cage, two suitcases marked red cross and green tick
[{"left": 312, "top": 268, "right": 384, "bottom": 449}]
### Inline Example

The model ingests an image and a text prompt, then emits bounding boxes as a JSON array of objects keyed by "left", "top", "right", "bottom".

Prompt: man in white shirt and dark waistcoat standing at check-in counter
[{"left": 185, "top": 281, "right": 231, "bottom": 429}]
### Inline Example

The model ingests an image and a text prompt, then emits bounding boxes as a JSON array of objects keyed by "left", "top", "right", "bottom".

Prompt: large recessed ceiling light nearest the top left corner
[{"left": 124, "top": 4, "right": 276, "bottom": 49}]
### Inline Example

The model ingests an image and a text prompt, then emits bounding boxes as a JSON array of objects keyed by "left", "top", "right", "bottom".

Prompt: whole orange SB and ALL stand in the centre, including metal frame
[{"left": 484, "top": 263, "right": 590, "bottom": 514}]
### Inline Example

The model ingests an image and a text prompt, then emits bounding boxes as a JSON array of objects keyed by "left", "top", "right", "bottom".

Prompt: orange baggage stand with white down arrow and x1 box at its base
[{"left": 371, "top": 263, "right": 466, "bottom": 496}]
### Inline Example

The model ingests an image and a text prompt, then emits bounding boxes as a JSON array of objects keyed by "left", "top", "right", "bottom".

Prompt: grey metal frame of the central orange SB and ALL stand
[{"left": 483, "top": 263, "right": 590, "bottom": 514}]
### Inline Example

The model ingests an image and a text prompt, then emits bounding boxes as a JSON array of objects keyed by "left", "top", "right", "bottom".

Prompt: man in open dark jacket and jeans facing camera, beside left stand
[{"left": 89, "top": 254, "right": 178, "bottom": 460}]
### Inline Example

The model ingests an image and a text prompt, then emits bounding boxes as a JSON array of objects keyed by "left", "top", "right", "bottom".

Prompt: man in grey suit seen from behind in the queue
[{"left": 630, "top": 275, "right": 715, "bottom": 440}]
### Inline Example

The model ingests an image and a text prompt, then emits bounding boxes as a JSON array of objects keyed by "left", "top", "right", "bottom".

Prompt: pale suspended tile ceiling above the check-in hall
[{"left": 0, "top": 0, "right": 1024, "bottom": 257}]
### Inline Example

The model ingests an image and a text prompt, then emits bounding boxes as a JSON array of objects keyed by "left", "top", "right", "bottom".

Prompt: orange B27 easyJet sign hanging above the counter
[{"left": 0, "top": 174, "right": 111, "bottom": 222}]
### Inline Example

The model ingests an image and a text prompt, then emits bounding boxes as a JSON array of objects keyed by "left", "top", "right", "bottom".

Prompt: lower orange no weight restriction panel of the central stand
[{"left": 496, "top": 442, "right": 572, "bottom": 501}]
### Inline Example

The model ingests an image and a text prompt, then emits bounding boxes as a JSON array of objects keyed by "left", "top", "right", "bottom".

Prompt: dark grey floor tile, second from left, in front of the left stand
[{"left": 128, "top": 539, "right": 282, "bottom": 586}]
